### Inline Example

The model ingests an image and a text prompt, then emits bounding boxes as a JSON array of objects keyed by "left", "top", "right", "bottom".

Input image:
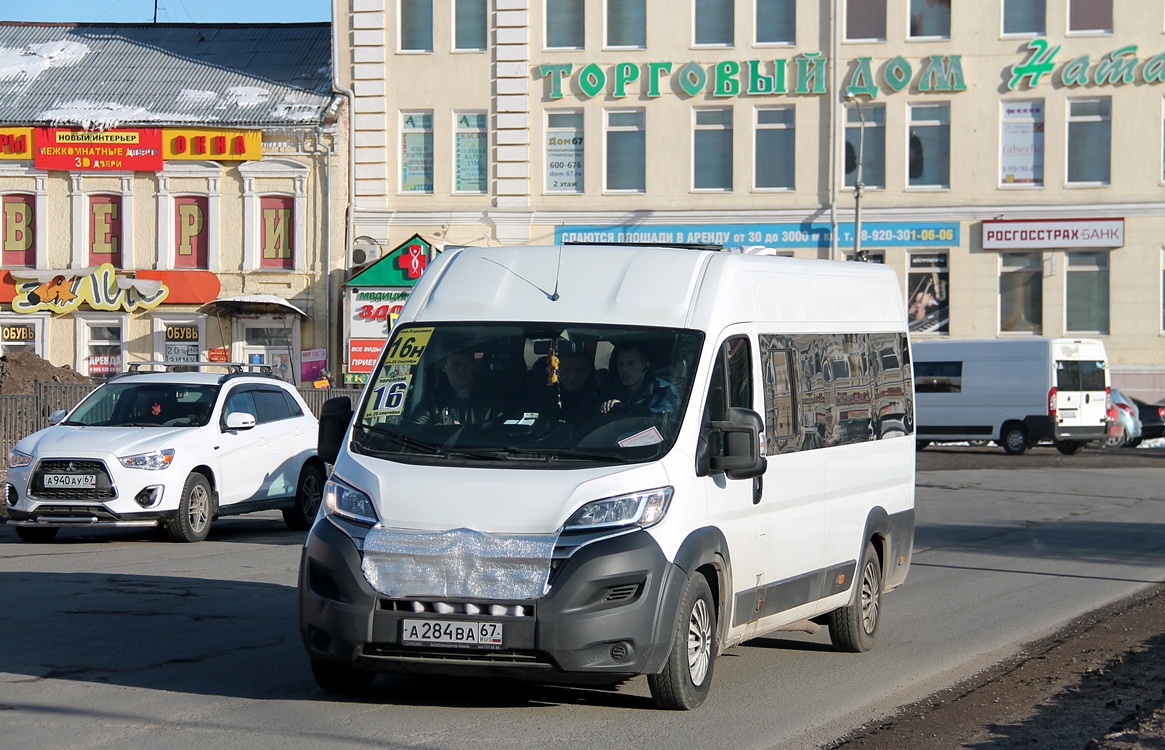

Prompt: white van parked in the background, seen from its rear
[{"left": 913, "top": 338, "right": 1110, "bottom": 455}]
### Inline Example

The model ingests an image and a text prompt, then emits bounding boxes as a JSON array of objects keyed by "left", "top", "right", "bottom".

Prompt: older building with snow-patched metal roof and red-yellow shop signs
[{"left": 0, "top": 23, "right": 347, "bottom": 383}]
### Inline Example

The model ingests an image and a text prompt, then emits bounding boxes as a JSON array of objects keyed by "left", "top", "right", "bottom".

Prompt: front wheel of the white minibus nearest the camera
[{"left": 648, "top": 571, "right": 718, "bottom": 710}]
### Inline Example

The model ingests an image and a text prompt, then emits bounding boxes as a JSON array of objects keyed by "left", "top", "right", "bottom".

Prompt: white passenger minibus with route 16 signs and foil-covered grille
[{"left": 299, "top": 246, "right": 915, "bottom": 708}]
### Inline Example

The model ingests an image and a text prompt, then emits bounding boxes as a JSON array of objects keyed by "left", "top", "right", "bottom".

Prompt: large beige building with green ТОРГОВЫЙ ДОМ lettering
[{"left": 333, "top": 0, "right": 1165, "bottom": 399}]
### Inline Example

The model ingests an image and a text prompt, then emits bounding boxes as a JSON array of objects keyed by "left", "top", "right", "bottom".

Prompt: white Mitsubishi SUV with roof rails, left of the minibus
[{"left": 3, "top": 365, "right": 325, "bottom": 542}]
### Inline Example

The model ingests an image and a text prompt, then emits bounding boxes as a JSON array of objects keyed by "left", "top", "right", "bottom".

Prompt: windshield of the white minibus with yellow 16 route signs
[{"left": 353, "top": 323, "right": 704, "bottom": 466}]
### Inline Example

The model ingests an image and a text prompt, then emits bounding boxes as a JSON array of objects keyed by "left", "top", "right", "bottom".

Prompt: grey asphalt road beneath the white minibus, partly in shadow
[{"left": 0, "top": 447, "right": 1165, "bottom": 750}]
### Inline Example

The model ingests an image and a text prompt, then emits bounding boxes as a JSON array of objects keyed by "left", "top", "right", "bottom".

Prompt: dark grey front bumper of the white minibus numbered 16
[{"left": 299, "top": 517, "right": 686, "bottom": 681}]
